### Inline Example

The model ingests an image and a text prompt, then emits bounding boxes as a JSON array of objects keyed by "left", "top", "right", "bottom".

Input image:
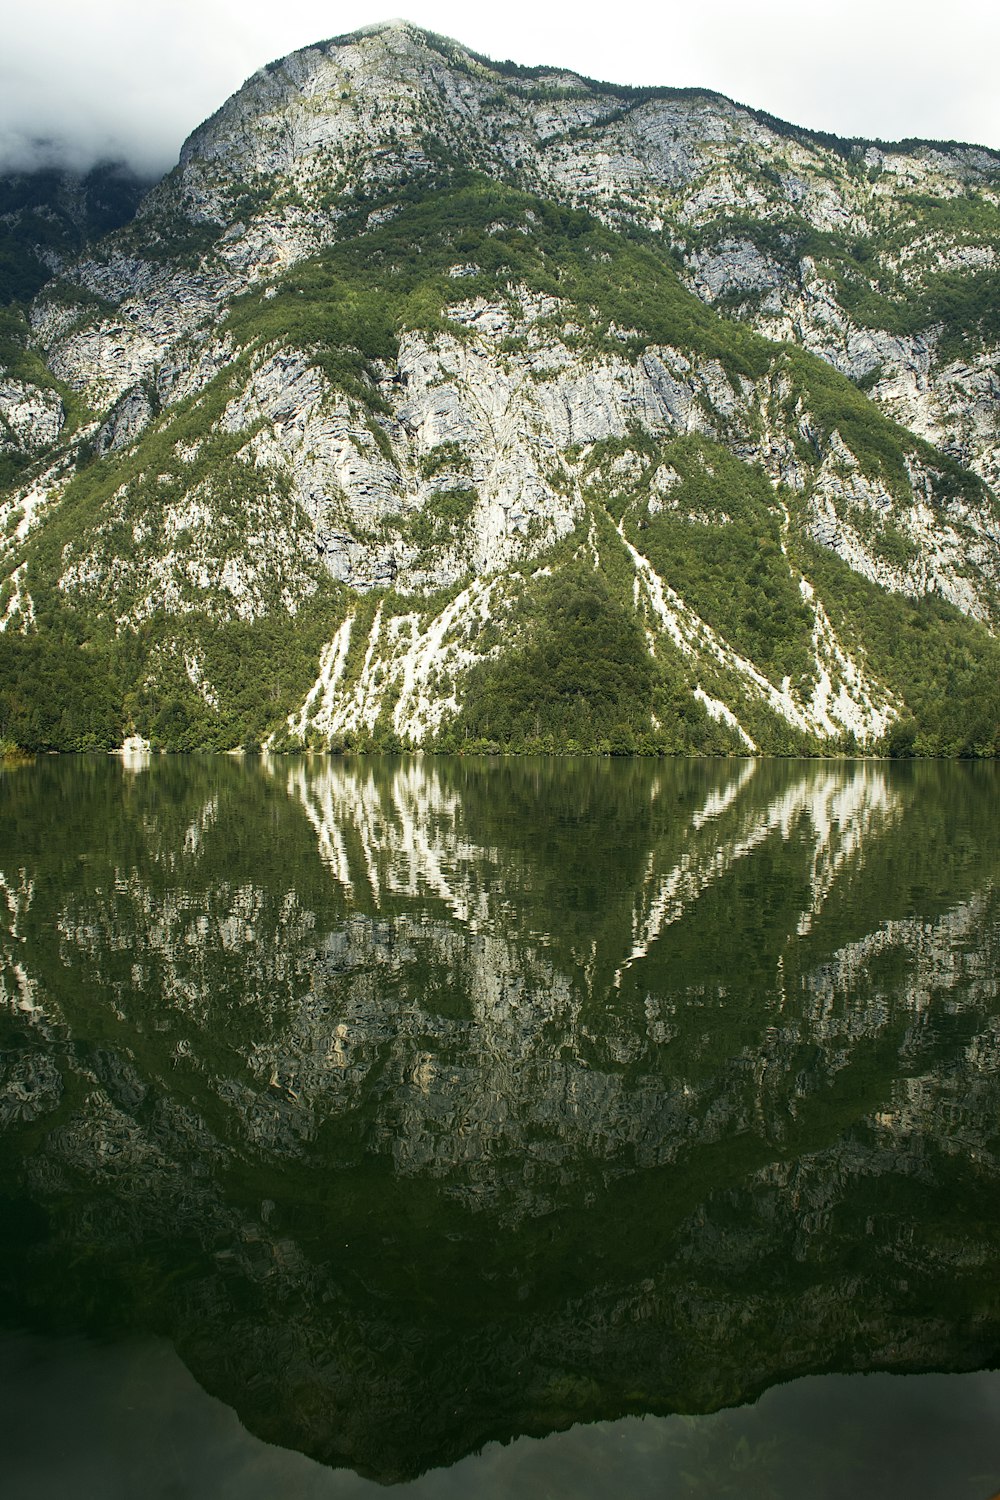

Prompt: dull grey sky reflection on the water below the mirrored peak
[{"left": 0, "top": 1335, "right": 1000, "bottom": 1500}]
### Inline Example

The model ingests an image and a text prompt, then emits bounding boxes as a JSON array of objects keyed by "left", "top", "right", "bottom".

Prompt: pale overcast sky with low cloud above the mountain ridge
[{"left": 0, "top": 0, "right": 1000, "bottom": 174}]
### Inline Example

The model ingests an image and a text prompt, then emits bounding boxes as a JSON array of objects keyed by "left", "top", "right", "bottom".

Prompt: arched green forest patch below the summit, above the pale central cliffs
[{"left": 229, "top": 173, "right": 771, "bottom": 377}]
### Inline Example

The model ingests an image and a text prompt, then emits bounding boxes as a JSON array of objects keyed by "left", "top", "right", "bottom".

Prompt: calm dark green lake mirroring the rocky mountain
[{"left": 0, "top": 758, "right": 1000, "bottom": 1500}]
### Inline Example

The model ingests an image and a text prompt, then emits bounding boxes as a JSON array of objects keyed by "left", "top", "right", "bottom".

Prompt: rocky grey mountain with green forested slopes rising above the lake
[{"left": 0, "top": 23, "right": 1000, "bottom": 755}]
